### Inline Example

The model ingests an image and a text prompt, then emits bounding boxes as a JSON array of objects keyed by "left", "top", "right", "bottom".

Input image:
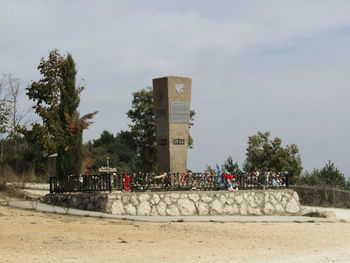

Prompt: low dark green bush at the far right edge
[{"left": 300, "top": 161, "right": 348, "bottom": 189}]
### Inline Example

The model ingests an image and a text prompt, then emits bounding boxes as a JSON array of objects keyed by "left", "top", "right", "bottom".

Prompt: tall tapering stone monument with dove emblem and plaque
[{"left": 153, "top": 76, "right": 192, "bottom": 172}]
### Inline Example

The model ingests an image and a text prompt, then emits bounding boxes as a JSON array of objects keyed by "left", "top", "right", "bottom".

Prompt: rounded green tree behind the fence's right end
[{"left": 244, "top": 132, "right": 303, "bottom": 182}]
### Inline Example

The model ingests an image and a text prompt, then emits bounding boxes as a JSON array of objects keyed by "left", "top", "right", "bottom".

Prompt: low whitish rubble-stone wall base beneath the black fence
[{"left": 42, "top": 189, "right": 301, "bottom": 216}]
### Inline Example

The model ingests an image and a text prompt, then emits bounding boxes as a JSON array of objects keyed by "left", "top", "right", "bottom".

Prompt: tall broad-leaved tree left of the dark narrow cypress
[{"left": 19, "top": 49, "right": 64, "bottom": 172}]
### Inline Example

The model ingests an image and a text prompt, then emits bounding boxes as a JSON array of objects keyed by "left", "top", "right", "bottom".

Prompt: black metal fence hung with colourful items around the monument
[{"left": 50, "top": 173, "right": 289, "bottom": 193}]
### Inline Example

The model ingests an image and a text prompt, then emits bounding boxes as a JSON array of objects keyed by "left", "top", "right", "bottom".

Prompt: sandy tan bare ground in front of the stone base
[{"left": 0, "top": 206, "right": 350, "bottom": 263}]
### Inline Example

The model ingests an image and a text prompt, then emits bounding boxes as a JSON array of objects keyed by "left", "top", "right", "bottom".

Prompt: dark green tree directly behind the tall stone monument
[{"left": 127, "top": 87, "right": 195, "bottom": 172}]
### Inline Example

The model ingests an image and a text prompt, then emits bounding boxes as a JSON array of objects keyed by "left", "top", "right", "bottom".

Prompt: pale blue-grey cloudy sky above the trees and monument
[{"left": 0, "top": 0, "right": 350, "bottom": 176}]
